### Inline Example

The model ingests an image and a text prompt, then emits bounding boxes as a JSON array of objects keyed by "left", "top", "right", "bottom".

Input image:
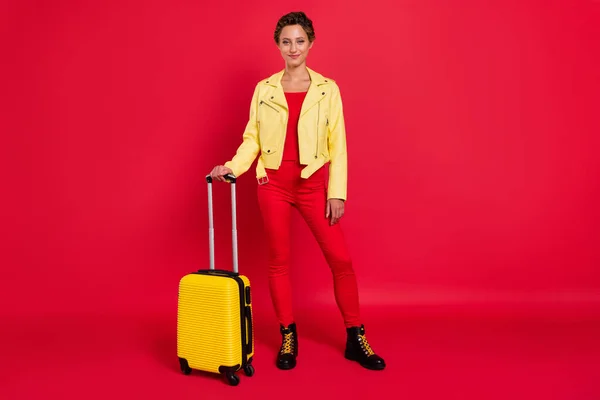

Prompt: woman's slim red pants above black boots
[{"left": 258, "top": 161, "right": 361, "bottom": 327}]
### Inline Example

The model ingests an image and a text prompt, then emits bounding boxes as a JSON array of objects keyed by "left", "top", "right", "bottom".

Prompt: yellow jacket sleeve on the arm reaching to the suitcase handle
[{"left": 224, "top": 85, "right": 260, "bottom": 177}]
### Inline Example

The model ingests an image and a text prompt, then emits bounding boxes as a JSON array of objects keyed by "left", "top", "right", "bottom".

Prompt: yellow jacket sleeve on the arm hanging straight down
[{"left": 327, "top": 84, "right": 348, "bottom": 200}]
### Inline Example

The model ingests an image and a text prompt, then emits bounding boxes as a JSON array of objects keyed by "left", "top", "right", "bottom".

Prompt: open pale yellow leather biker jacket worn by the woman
[{"left": 225, "top": 69, "right": 348, "bottom": 200}]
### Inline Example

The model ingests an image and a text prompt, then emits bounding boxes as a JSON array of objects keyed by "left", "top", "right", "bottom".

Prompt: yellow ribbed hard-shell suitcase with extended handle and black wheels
[{"left": 177, "top": 175, "right": 254, "bottom": 386}]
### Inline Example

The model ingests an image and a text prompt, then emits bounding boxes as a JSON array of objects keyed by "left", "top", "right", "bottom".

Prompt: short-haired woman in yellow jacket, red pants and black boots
[{"left": 210, "top": 12, "right": 385, "bottom": 370}]
